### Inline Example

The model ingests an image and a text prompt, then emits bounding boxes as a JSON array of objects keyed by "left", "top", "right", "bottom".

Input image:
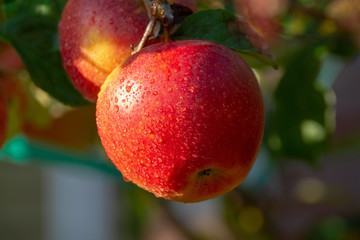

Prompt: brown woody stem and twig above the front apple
[{"left": 132, "top": 0, "right": 174, "bottom": 54}]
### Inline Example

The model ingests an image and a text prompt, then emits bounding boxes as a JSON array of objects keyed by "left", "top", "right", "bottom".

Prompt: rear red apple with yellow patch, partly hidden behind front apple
[{"left": 59, "top": 0, "right": 196, "bottom": 102}]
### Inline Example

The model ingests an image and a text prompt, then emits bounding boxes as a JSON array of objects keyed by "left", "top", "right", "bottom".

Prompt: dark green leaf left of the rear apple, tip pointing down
[{"left": 0, "top": 15, "right": 87, "bottom": 105}]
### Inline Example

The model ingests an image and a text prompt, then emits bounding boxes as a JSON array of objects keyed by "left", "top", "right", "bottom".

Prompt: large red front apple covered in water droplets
[{"left": 96, "top": 40, "right": 264, "bottom": 202}]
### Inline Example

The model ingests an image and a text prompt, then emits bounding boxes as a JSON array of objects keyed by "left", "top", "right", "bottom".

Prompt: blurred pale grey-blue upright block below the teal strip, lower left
[{"left": 43, "top": 166, "right": 117, "bottom": 240}]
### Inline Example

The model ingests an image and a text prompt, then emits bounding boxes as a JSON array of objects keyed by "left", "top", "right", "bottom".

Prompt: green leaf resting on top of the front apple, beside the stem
[{"left": 173, "top": 9, "right": 278, "bottom": 68}]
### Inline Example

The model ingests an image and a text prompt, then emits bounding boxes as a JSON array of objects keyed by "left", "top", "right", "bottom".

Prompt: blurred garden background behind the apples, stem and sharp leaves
[{"left": 0, "top": 0, "right": 360, "bottom": 240}]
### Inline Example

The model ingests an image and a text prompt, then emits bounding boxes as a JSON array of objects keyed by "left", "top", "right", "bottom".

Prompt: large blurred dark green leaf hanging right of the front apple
[{"left": 266, "top": 44, "right": 334, "bottom": 163}]
